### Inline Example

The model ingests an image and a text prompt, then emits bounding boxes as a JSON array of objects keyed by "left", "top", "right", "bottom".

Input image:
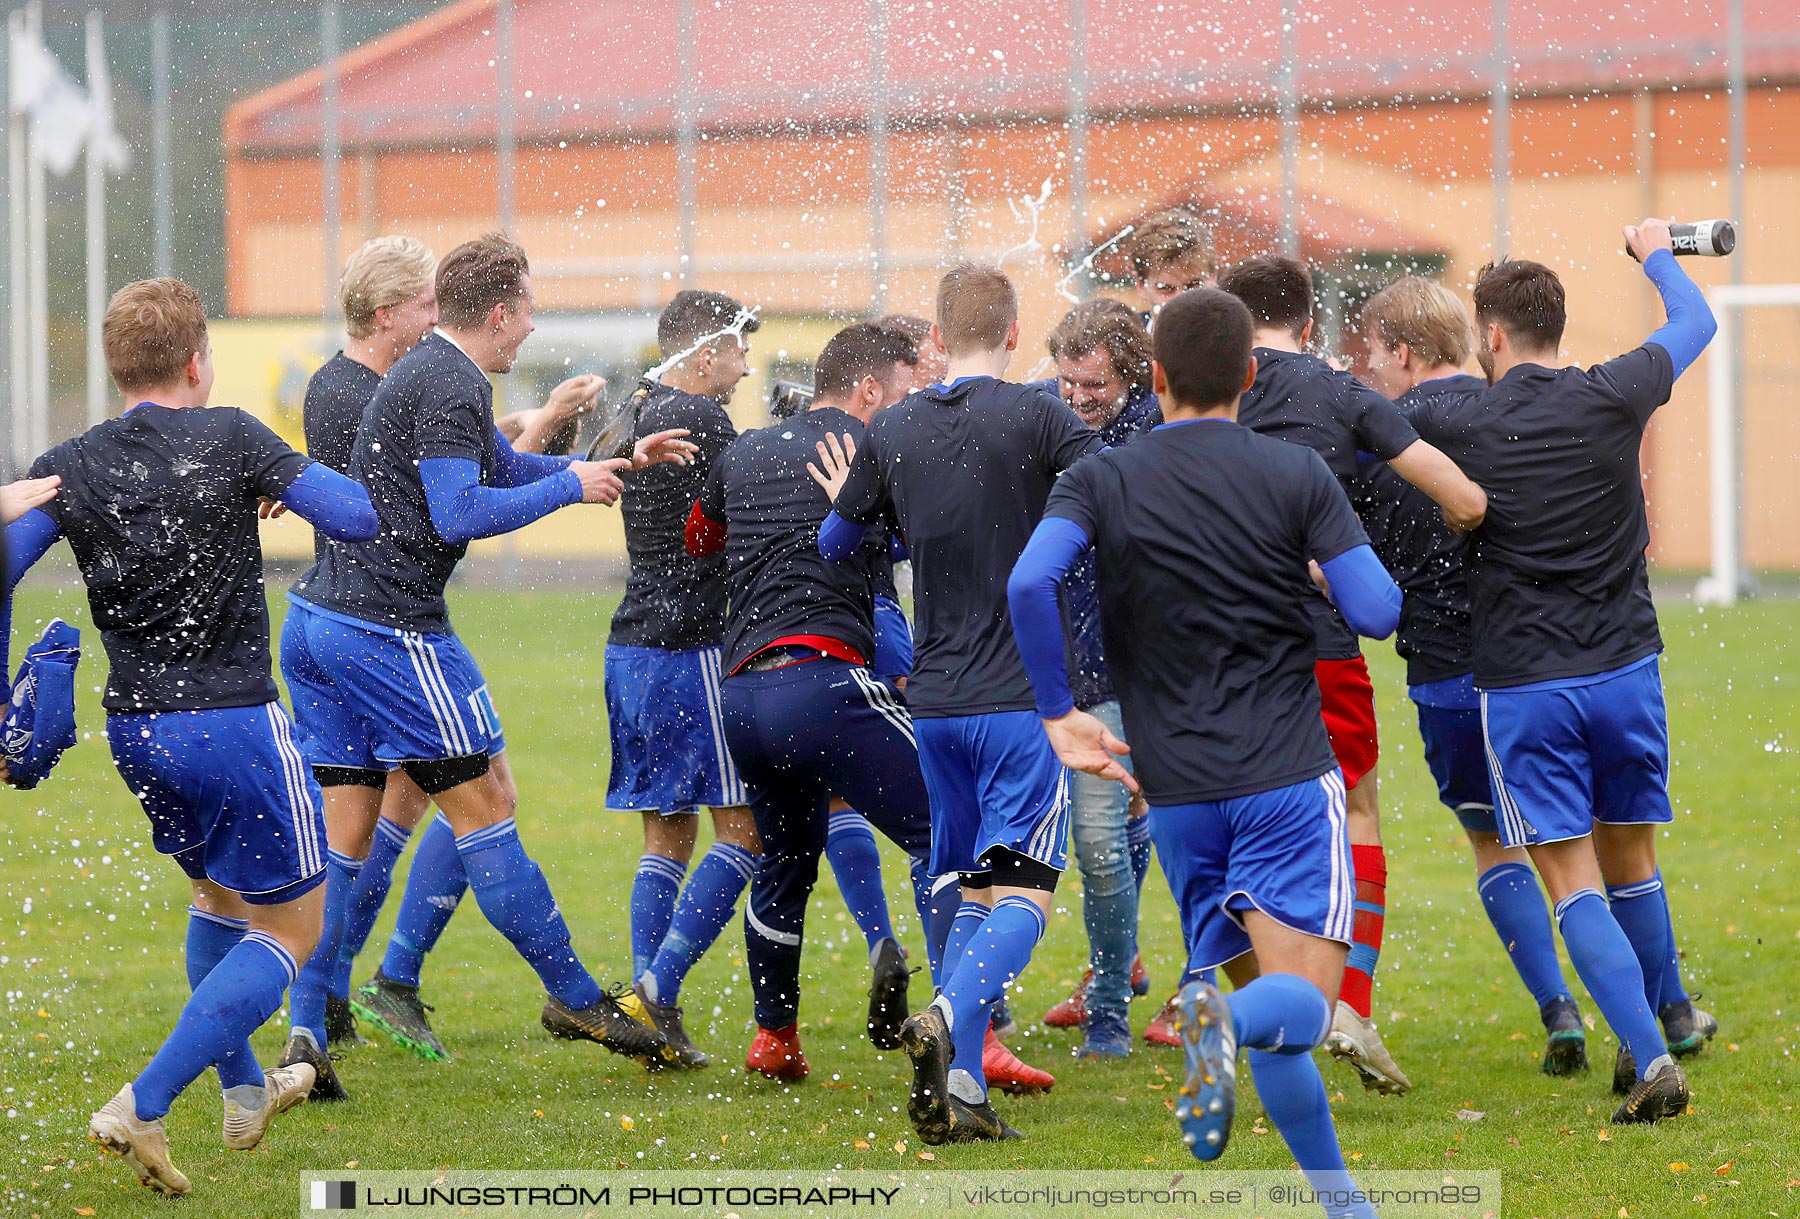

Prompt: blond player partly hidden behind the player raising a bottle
[{"left": 1350, "top": 275, "right": 1588, "bottom": 1075}]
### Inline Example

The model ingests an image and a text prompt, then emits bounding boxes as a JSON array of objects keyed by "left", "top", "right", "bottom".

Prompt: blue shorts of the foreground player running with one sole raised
[{"left": 1150, "top": 767, "right": 1355, "bottom": 969}]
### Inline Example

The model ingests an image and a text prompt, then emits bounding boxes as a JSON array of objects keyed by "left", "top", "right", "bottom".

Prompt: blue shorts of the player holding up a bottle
[{"left": 1481, "top": 657, "right": 1674, "bottom": 846}]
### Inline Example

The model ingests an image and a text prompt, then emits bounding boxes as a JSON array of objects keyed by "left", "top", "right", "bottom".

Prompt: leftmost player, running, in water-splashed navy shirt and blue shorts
[{"left": 0, "top": 279, "right": 376, "bottom": 1194}]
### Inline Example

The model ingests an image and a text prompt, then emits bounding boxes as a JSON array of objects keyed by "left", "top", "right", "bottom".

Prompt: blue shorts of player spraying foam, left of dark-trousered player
[{"left": 607, "top": 643, "right": 751, "bottom": 816}]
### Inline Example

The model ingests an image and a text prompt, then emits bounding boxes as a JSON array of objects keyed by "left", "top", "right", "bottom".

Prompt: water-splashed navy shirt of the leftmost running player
[{"left": 29, "top": 402, "right": 311, "bottom": 711}]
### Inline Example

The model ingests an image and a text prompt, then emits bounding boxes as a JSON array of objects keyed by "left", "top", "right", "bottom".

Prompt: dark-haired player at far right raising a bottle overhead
[{"left": 1413, "top": 218, "right": 1717, "bottom": 1122}]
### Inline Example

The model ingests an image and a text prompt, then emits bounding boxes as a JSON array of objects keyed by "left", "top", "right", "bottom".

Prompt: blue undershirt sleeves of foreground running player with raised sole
[{"left": 1006, "top": 517, "right": 1400, "bottom": 720}]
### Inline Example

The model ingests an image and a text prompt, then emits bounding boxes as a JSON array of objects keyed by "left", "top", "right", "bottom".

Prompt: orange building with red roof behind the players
[{"left": 3, "top": 0, "right": 1800, "bottom": 571}]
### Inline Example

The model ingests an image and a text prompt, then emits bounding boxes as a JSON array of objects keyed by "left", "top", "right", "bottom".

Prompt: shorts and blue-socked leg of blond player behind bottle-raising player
[{"left": 1418, "top": 698, "right": 1588, "bottom": 1075}]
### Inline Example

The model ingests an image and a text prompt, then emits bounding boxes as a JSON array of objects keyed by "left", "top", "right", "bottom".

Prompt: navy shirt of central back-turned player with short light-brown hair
[{"left": 837, "top": 376, "right": 1102, "bottom": 717}]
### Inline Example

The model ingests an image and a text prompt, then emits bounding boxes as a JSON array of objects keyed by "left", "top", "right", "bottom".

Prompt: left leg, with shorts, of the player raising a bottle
[{"left": 1481, "top": 690, "right": 1687, "bottom": 1122}]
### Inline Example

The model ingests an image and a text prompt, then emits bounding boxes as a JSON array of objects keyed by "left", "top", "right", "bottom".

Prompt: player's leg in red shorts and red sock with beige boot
[{"left": 1314, "top": 655, "right": 1411, "bottom": 1097}]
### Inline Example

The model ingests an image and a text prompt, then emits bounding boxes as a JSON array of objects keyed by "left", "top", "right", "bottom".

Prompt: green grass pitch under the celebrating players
[{"left": 0, "top": 583, "right": 1800, "bottom": 1219}]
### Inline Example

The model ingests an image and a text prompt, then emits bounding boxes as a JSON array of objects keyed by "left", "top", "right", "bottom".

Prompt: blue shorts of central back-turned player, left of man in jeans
[{"left": 913, "top": 711, "right": 1069, "bottom": 877}]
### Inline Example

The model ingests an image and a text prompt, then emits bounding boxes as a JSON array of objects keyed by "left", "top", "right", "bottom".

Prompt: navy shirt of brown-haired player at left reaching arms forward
[{"left": 293, "top": 335, "right": 497, "bottom": 634}]
